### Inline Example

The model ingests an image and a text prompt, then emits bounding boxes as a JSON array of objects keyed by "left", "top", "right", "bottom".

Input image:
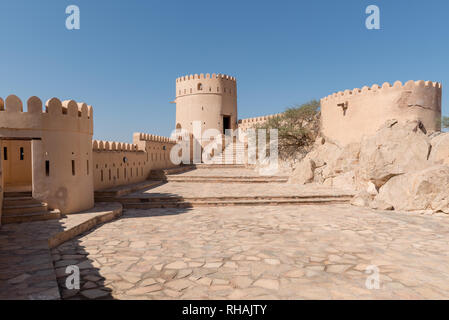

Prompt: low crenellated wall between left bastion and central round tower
[{"left": 92, "top": 133, "right": 176, "bottom": 190}]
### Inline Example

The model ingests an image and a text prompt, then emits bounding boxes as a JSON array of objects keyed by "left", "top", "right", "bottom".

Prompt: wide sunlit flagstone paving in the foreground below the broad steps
[{"left": 52, "top": 204, "right": 449, "bottom": 299}]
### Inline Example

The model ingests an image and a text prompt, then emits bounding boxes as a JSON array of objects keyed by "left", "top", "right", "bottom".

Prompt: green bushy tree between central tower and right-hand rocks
[{"left": 254, "top": 100, "right": 320, "bottom": 159}]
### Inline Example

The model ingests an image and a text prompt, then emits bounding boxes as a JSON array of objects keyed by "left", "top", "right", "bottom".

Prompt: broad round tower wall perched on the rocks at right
[{"left": 321, "top": 80, "right": 442, "bottom": 145}]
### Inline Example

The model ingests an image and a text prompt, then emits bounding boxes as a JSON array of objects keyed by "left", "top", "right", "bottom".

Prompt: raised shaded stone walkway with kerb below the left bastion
[{"left": 0, "top": 203, "right": 122, "bottom": 299}]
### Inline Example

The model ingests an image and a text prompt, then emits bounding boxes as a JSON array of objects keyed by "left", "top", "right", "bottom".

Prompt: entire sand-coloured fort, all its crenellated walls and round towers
[{"left": 0, "top": 73, "right": 442, "bottom": 225}]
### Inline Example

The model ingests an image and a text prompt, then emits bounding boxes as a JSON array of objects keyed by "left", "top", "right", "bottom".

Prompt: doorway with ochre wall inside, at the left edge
[{"left": 1, "top": 139, "right": 32, "bottom": 192}]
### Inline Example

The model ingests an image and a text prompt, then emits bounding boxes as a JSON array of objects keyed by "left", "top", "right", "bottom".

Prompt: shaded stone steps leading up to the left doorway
[{"left": 2, "top": 191, "right": 61, "bottom": 224}]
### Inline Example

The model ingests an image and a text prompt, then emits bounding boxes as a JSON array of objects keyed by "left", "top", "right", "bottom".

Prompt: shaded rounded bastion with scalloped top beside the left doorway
[{"left": 0, "top": 95, "right": 94, "bottom": 213}]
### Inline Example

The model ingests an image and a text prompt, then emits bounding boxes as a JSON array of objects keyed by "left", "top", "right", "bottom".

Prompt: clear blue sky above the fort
[{"left": 0, "top": 0, "right": 449, "bottom": 142}]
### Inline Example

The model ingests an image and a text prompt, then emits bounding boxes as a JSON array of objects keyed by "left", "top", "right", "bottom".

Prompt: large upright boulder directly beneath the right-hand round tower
[{"left": 356, "top": 120, "right": 431, "bottom": 189}]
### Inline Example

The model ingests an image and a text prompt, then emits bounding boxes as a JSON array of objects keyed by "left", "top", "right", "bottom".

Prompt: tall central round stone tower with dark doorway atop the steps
[{"left": 175, "top": 73, "right": 237, "bottom": 144}]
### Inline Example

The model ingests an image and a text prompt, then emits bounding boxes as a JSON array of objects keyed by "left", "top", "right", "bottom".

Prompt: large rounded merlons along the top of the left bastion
[{"left": 0, "top": 95, "right": 93, "bottom": 134}]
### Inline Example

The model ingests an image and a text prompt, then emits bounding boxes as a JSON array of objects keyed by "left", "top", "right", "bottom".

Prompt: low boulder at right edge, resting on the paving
[{"left": 375, "top": 165, "right": 449, "bottom": 213}]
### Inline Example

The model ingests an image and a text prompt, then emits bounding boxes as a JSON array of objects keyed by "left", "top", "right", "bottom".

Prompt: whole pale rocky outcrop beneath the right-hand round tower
[{"left": 290, "top": 120, "right": 449, "bottom": 213}]
